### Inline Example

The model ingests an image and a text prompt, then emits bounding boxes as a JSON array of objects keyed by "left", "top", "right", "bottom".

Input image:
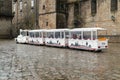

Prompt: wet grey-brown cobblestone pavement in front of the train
[{"left": 0, "top": 40, "right": 120, "bottom": 80}]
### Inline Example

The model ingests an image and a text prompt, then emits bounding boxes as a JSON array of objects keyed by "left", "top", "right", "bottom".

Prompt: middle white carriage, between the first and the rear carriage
[{"left": 45, "top": 29, "right": 69, "bottom": 47}]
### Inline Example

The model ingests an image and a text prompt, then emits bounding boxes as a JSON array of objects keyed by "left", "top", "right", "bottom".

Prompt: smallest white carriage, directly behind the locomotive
[{"left": 29, "top": 29, "right": 45, "bottom": 45}]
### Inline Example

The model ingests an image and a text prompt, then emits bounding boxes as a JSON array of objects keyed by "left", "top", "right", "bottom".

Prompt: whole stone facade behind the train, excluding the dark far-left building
[{"left": 13, "top": 0, "right": 120, "bottom": 36}]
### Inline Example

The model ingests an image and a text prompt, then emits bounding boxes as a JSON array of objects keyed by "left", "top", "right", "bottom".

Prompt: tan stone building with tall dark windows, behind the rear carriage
[{"left": 67, "top": 0, "right": 120, "bottom": 36}]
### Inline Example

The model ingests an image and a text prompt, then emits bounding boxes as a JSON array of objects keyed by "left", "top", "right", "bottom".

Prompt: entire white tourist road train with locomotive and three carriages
[{"left": 15, "top": 28, "right": 108, "bottom": 51}]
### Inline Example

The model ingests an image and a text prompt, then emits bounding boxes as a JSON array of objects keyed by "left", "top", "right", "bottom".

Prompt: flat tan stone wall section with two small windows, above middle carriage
[{"left": 39, "top": 0, "right": 56, "bottom": 29}]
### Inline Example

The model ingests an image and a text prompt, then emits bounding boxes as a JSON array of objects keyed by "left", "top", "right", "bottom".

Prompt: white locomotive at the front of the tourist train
[{"left": 15, "top": 29, "right": 29, "bottom": 43}]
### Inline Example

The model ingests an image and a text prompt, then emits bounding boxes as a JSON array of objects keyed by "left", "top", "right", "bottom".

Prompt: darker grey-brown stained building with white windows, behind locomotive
[{"left": 12, "top": 0, "right": 39, "bottom": 35}]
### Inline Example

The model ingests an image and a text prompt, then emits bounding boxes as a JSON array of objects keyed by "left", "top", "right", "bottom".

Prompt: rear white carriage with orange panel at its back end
[{"left": 68, "top": 28, "right": 108, "bottom": 51}]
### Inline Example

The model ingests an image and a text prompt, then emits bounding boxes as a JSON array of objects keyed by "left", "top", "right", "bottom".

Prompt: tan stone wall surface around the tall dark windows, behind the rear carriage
[{"left": 68, "top": 0, "right": 120, "bottom": 35}]
